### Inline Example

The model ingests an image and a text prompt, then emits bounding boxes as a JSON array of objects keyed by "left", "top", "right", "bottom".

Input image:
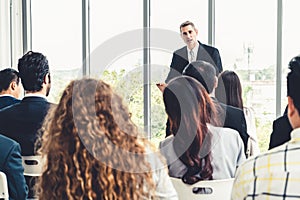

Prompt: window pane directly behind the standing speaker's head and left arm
[{"left": 150, "top": 0, "right": 208, "bottom": 143}]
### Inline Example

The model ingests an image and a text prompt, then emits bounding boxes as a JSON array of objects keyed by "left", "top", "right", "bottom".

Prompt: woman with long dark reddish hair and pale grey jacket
[{"left": 160, "top": 76, "right": 246, "bottom": 184}]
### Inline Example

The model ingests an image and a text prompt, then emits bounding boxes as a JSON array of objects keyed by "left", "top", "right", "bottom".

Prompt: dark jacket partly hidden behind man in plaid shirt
[{"left": 269, "top": 115, "right": 293, "bottom": 149}]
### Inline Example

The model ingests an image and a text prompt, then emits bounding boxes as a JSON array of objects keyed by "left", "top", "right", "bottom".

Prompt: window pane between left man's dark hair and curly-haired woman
[{"left": 31, "top": 0, "right": 82, "bottom": 103}]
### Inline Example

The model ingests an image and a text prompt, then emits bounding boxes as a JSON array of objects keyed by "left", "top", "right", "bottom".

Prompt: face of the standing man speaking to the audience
[{"left": 180, "top": 25, "right": 198, "bottom": 49}]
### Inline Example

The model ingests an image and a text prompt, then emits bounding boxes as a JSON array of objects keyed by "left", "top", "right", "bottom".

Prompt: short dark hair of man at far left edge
[{"left": 0, "top": 68, "right": 20, "bottom": 92}]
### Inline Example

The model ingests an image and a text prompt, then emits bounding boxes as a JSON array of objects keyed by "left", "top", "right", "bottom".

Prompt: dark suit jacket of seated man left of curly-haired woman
[{"left": 0, "top": 97, "right": 51, "bottom": 156}]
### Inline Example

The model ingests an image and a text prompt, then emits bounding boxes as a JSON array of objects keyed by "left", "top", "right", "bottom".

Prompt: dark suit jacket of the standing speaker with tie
[{"left": 165, "top": 41, "right": 223, "bottom": 83}]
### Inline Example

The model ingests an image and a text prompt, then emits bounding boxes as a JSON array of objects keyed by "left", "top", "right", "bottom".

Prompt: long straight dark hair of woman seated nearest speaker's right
[{"left": 215, "top": 70, "right": 243, "bottom": 109}]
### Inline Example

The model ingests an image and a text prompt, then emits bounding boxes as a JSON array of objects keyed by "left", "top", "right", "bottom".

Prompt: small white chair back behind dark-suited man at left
[{"left": 22, "top": 155, "right": 43, "bottom": 176}]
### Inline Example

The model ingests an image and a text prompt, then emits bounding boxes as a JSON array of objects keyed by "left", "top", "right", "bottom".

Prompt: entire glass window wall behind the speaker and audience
[{"left": 0, "top": 0, "right": 300, "bottom": 151}]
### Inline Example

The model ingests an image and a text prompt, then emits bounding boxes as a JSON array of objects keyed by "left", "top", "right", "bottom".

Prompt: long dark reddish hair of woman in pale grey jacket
[{"left": 163, "top": 76, "right": 216, "bottom": 184}]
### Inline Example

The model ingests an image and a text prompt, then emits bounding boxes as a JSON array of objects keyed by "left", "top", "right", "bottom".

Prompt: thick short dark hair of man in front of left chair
[{"left": 18, "top": 51, "right": 49, "bottom": 92}]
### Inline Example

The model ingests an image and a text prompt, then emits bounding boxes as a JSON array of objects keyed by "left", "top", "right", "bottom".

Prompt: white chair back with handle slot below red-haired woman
[{"left": 171, "top": 178, "right": 234, "bottom": 200}]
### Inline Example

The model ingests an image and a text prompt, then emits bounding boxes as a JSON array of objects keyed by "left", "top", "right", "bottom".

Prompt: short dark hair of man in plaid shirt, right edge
[{"left": 287, "top": 56, "right": 300, "bottom": 112}]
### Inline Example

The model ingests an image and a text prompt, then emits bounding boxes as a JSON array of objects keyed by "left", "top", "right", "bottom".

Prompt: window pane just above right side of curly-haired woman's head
[{"left": 88, "top": 0, "right": 144, "bottom": 134}]
